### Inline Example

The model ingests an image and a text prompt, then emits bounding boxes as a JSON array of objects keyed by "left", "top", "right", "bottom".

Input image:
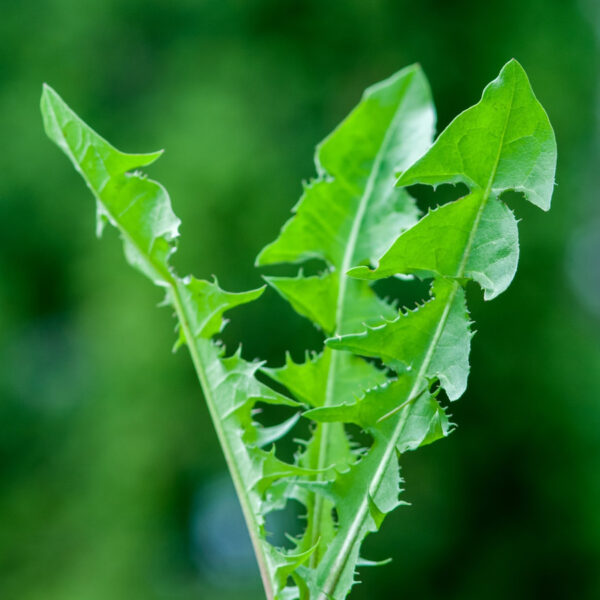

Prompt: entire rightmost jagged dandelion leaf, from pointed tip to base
[{"left": 288, "top": 61, "right": 556, "bottom": 600}]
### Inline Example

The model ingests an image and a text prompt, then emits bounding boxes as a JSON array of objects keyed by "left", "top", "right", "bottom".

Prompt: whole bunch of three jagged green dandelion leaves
[{"left": 42, "top": 60, "right": 556, "bottom": 600}]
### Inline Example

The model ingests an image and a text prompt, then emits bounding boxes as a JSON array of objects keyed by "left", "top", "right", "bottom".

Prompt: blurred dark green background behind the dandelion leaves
[{"left": 0, "top": 0, "right": 600, "bottom": 600}]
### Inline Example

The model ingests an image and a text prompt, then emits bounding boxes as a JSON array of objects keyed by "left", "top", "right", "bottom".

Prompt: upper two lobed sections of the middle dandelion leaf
[{"left": 256, "top": 66, "right": 434, "bottom": 333}]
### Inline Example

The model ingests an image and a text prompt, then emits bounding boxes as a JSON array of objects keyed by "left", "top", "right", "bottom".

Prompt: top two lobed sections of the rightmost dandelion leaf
[{"left": 350, "top": 60, "right": 556, "bottom": 300}]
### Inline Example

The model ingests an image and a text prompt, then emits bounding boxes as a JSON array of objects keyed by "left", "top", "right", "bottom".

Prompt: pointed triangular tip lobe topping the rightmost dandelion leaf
[{"left": 398, "top": 59, "right": 556, "bottom": 210}]
